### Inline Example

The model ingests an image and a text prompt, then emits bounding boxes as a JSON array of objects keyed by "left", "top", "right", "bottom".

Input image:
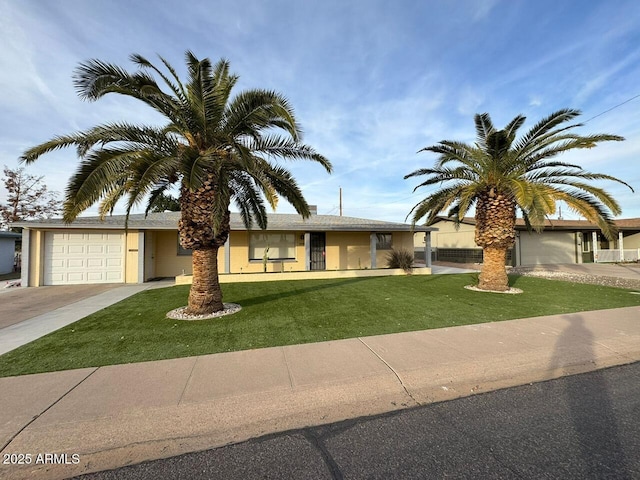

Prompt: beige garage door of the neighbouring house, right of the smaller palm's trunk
[{"left": 519, "top": 231, "right": 576, "bottom": 265}]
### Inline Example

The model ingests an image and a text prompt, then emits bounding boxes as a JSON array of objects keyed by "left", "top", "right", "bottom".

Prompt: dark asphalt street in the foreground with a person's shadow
[{"left": 77, "top": 363, "right": 640, "bottom": 480}]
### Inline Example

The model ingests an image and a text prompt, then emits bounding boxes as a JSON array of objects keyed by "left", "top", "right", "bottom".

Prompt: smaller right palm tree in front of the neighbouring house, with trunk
[{"left": 404, "top": 109, "right": 633, "bottom": 291}]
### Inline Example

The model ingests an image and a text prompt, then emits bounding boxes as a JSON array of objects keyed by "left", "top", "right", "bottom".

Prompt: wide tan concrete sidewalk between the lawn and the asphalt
[{"left": 0, "top": 307, "right": 640, "bottom": 479}]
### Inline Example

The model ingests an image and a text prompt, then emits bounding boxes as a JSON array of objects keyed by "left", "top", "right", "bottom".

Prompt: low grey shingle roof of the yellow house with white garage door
[{"left": 14, "top": 212, "right": 436, "bottom": 232}]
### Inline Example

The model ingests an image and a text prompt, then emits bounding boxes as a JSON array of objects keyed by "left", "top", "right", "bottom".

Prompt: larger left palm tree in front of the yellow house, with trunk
[{"left": 21, "top": 51, "right": 331, "bottom": 315}]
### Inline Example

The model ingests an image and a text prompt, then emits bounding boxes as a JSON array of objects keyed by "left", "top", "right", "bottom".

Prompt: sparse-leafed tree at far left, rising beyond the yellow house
[{"left": 0, "top": 165, "right": 62, "bottom": 230}]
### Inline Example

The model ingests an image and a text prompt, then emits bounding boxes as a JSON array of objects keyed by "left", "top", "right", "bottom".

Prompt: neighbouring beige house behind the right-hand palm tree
[{"left": 414, "top": 217, "right": 640, "bottom": 266}]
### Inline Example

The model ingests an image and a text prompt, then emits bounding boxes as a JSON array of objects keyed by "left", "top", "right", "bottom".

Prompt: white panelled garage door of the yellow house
[{"left": 44, "top": 232, "right": 125, "bottom": 285}]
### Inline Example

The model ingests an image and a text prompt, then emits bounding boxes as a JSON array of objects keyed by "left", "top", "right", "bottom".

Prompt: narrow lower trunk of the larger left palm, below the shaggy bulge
[{"left": 185, "top": 245, "right": 224, "bottom": 315}]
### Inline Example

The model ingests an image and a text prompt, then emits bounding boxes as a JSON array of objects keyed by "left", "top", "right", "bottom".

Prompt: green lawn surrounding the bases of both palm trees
[{"left": 0, "top": 275, "right": 640, "bottom": 376}]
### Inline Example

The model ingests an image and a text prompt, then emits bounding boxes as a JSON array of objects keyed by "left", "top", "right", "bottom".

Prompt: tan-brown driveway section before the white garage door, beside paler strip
[{"left": 0, "top": 283, "right": 122, "bottom": 329}]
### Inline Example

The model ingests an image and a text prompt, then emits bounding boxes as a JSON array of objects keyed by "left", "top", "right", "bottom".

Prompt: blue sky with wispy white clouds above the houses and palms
[{"left": 0, "top": 0, "right": 640, "bottom": 221}]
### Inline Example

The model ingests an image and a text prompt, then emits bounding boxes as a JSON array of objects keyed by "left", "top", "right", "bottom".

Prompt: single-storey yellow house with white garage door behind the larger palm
[{"left": 16, "top": 212, "right": 433, "bottom": 286}]
